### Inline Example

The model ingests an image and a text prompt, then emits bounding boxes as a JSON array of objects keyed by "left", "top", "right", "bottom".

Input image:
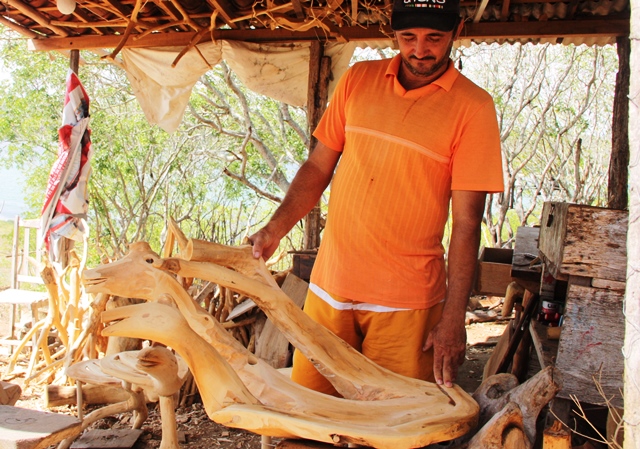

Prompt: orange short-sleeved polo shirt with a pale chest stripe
[{"left": 311, "top": 56, "right": 503, "bottom": 309}]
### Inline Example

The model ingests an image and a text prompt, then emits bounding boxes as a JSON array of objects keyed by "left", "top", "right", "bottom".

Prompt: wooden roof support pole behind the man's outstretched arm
[{"left": 303, "top": 41, "right": 331, "bottom": 250}]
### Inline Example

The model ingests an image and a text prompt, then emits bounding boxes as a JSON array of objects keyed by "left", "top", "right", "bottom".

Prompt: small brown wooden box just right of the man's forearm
[{"left": 474, "top": 248, "right": 513, "bottom": 296}]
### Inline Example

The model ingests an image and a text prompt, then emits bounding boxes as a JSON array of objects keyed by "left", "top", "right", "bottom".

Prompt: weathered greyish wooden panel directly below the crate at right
[{"left": 556, "top": 284, "right": 625, "bottom": 407}]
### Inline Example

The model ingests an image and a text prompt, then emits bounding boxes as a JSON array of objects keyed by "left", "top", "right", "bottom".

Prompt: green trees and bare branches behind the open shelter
[{"left": 0, "top": 23, "right": 617, "bottom": 263}]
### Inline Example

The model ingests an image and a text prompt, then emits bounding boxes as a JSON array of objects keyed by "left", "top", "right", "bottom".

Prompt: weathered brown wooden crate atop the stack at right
[{"left": 539, "top": 202, "right": 629, "bottom": 282}]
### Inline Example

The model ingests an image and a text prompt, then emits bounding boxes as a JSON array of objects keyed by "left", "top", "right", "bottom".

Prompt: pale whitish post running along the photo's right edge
[{"left": 623, "top": 4, "right": 640, "bottom": 448}]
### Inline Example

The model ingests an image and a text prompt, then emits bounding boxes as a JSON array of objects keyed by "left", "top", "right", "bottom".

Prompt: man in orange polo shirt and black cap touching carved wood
[{"left": 249, "top": 0, "right": 503, "bottom": 394}]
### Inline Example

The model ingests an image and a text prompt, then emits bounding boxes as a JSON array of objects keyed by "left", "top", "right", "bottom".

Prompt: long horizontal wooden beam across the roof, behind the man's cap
[{"left": 26, "top": 18, "right": 629, "bottom": 51}]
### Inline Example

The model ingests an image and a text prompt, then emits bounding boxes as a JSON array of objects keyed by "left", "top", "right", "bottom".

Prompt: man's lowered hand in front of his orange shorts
[{"left": 422, "top": 320, "right": 467, "bottom": 387}]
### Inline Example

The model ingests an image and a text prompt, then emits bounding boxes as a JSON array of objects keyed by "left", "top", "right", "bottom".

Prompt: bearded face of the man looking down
[{"left": 396, "top": 28, "right": 457, "bottom": 78}]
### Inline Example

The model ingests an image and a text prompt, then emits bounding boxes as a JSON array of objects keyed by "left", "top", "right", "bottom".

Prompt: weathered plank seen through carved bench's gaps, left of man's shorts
[{"left": 256, "top": 273, "right": 309, "bottom": 368}]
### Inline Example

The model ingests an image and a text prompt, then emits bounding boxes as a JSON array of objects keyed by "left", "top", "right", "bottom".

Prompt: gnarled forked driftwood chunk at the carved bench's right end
[{"left": 473, "top": 366, "right": 562, "bottom": 443}]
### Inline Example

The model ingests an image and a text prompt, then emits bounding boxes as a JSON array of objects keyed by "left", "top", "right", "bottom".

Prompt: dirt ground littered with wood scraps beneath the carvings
[{"left": 0, "top": 308, "right": 505, "bottom": 449}]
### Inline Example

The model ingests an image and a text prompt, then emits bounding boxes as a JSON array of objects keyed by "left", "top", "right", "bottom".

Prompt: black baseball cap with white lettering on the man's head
[{"left": 391, "top": 0, "right": 460, "bottom": 31}]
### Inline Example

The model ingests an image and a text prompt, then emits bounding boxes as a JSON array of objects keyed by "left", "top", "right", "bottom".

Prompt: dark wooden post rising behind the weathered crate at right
[{"left": 608, "top": 36, "right": 631, "bottom": 209}]
